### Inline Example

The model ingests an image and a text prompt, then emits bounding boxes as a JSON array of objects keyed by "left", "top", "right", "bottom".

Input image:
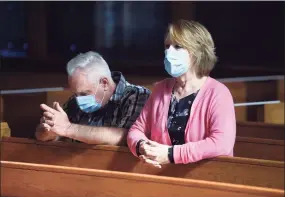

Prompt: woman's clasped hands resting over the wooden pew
[{"left": 139, "top": 140, "right": 170, "bottom": 168}]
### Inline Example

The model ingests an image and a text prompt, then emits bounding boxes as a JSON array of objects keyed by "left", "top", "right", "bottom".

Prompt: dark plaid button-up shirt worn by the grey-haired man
[{"left": 63, "top": 72, "right": 151, "bottom": 129}]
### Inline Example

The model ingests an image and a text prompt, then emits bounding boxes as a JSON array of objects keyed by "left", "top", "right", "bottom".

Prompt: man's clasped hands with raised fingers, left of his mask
[{"left": 40, "top": 102, "right": 71, "bottom": 136}]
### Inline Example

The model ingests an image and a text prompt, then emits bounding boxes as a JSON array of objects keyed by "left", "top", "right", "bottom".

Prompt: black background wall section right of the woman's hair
[{"left": 196, "top": 1, "right": 285, "bottom": 68}]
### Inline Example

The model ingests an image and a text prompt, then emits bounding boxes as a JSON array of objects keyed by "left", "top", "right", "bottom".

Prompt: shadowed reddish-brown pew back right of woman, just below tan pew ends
[{"left": 237, "top": 122, "right": 285, "bottom": 140}]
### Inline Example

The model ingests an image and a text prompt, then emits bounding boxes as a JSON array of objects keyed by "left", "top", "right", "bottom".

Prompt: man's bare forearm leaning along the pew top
[{"left": 65, "top": 124, "right": 127, "bottom": 146}]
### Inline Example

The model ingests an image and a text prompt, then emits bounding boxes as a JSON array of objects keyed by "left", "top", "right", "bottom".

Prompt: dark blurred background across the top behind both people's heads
[{"left": 0, "top": 1, "right": 284, "bottom": 77}]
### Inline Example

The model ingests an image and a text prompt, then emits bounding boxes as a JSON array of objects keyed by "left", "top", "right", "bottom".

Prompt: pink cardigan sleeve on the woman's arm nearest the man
[{"left": 127, "top": 84, "right": 153, "bottom": 156}]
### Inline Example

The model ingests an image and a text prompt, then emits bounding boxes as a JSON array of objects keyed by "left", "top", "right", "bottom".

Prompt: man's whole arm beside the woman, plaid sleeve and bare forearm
[{"left": 59, "top": 88, "right": 150, "bottom": 146}]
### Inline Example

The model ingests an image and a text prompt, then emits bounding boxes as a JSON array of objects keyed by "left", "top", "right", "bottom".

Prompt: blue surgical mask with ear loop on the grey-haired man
[{"left": 76, "top": 83, "right": 105, "bottom": 113}]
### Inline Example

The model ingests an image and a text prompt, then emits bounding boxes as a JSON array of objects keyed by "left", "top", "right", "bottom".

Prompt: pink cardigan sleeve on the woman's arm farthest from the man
[{"left": 173, "top": 88, "right": 236, "bottom": 164}]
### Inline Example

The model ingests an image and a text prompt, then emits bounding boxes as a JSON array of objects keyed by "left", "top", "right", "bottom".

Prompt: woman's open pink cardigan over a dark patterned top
[{"left": 127, "top": 77, "right": 236, "bottom": 164}]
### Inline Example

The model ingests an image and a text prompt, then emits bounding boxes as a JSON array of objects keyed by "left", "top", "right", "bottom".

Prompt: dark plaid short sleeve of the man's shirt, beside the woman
[{"left": 118, "top": 87, "right": 150, "bottom": 129}]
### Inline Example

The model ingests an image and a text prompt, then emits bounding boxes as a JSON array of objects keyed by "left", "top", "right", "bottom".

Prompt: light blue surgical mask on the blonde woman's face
[{"left": 164, "top": 45, "right": 190, "bottom": 77}]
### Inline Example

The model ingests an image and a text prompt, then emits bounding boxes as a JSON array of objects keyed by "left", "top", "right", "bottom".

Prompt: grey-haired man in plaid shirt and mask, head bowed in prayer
[{"left": 35, "top": 52, "right": 150, "bottom": 145}]
